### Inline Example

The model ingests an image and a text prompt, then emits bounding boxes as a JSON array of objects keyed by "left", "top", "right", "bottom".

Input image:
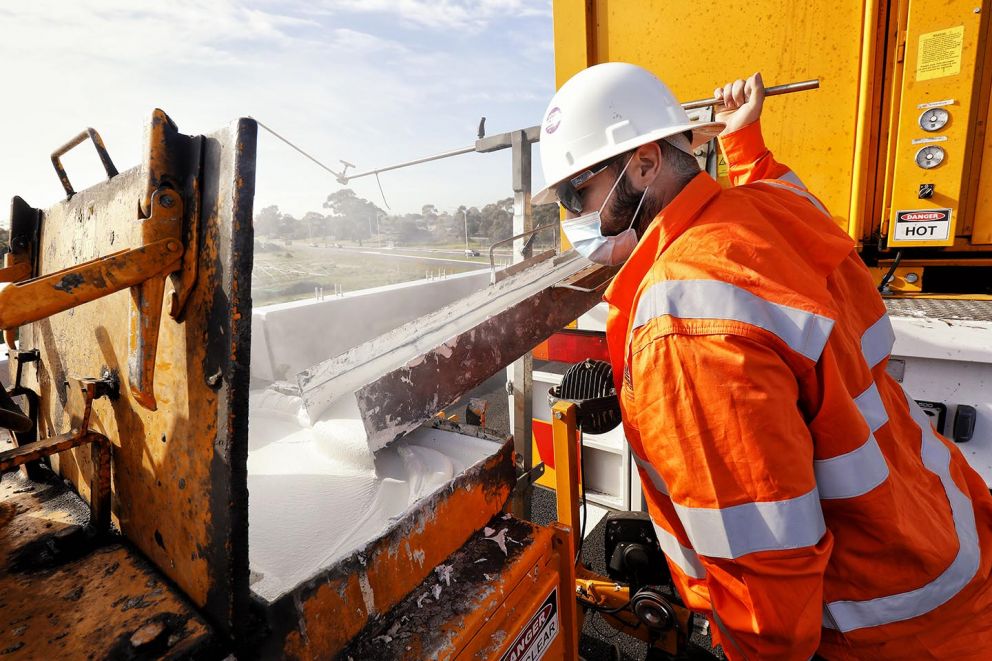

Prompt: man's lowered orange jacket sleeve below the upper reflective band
[{"left": 630, "top": 335, "right": 833, "bottom": 661}]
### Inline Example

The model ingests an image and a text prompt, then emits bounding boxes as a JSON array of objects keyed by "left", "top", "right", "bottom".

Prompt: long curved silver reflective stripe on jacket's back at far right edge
[{"left": 823, "top": 392, "right": 981, "bottom": 632}]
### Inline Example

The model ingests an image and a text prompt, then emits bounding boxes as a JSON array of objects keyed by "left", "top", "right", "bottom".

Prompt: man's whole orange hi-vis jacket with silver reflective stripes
[{"left": 606, "top": 123, "right": 992, "bottom": 661}]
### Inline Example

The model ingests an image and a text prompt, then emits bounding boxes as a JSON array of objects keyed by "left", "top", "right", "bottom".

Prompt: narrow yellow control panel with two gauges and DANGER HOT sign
[{"left": 886, "top": 0, "right": 982, "bottom": 247}]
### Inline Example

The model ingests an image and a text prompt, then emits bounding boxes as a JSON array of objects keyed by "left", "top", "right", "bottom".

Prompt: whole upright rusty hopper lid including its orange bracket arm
[{"left": 10, "top": 111, "right": 256, "bottom": 645}]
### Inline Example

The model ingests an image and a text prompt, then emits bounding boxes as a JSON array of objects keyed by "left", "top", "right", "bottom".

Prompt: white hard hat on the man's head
[{"left": 533, "top": 62, "right": 724, "bottom": 204}]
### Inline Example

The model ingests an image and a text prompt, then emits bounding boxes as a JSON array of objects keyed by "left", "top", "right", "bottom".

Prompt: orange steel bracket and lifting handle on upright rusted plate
[{"left": 0, "top": 109, "right": 202, "bottom": 411}]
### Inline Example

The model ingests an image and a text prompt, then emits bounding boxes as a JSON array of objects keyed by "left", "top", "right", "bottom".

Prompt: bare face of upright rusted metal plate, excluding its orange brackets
[{"left": 14, "top": 114, "right": 257, "bottom": 637}]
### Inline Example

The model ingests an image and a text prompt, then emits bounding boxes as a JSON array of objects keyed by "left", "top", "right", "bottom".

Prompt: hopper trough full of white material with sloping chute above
[{"left": 248, "top": 253, "right": 612, "bottom": 651}]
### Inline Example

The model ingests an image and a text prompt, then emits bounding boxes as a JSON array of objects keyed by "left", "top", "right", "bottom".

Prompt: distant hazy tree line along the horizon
[{"left": 255, "top": 188, "right": 558, "bottom": 246}]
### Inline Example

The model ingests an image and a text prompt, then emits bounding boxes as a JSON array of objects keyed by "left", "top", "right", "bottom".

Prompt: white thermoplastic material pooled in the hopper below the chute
[{"left": 248, "top": 390, "right": 500, "bottom": 601}]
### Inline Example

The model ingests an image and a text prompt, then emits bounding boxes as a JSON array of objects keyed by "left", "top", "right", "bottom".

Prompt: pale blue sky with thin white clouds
[{"left": 0, "top": 0, "right": 554, "bottom": 218}]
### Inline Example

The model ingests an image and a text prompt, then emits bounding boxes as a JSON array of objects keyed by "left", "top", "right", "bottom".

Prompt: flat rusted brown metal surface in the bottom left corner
[{"left": 0, "top": 466, "right": 216, "bottom": 659}]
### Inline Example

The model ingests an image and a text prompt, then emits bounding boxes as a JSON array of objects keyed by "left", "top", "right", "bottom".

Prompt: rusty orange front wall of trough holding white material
[{"left": 256, "top": 426, "right": 514, "bottom": 659}]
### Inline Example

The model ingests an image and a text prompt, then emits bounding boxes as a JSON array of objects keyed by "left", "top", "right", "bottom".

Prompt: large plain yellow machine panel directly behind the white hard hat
[{"left": 554, "top": 0, "right": 875, "bottom": 235}]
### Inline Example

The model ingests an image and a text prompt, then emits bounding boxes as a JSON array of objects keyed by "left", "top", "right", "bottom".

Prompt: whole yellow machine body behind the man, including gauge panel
[{"left": 554, "top": 0, "right": 992, "bottom": 294}]
